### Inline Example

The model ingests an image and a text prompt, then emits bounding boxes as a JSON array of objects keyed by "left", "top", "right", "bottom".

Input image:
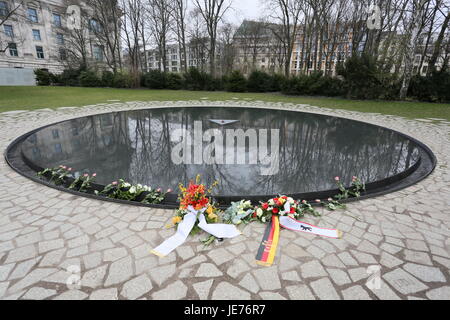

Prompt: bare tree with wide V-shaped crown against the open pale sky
[{"left": 194, "top": 0, "right": 232, "bottom": 77}]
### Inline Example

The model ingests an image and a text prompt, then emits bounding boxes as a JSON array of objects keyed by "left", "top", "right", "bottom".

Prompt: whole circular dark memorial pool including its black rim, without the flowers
[{"left": 6, "top": 107, "right": 436, "bottom": 206}]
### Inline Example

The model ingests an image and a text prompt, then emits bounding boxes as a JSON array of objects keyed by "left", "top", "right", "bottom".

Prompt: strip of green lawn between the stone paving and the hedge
[{"left": 0, "top": 87, "right": 450, "bottom": 120}]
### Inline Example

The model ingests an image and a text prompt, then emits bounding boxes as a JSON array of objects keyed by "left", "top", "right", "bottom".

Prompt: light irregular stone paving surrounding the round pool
[{"left": 0, "top": 100, "right": 450, "bottom": 300}]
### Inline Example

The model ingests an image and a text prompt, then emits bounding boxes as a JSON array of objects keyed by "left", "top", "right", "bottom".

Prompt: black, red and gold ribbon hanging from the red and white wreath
[{"left": 256, "top": 215, "right": 280, "bottom": 267}]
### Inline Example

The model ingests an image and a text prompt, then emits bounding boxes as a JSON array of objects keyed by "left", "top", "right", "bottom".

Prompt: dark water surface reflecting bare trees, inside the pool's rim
[{"left": 22, "top": 108, "right": 419, "bottom": 196}]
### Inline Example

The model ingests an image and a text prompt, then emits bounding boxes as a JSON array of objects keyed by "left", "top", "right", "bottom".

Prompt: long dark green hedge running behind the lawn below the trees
[{"left": 35, "top": 63, "right": 450, "bottom": 102}]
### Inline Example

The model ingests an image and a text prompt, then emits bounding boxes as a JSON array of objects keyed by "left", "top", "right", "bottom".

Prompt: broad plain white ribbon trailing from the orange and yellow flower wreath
[{"left": 152, "top": 206, "right": 241, "bottom": 257}]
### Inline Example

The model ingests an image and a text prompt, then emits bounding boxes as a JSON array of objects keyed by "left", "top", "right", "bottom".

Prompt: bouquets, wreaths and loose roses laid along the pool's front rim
[{"left": 38, "top": 166, "right": 365, "bottom": 244}]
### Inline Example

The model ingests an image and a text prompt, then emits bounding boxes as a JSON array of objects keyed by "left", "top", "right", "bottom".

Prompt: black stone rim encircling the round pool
[{"left": 4, "top": 105, "right": 437, "bottom": 209}]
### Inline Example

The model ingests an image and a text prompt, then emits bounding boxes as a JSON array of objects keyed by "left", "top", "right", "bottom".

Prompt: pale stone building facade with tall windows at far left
[{"left": 0, "top": 0, "right": 110, "bottom": 73}]
